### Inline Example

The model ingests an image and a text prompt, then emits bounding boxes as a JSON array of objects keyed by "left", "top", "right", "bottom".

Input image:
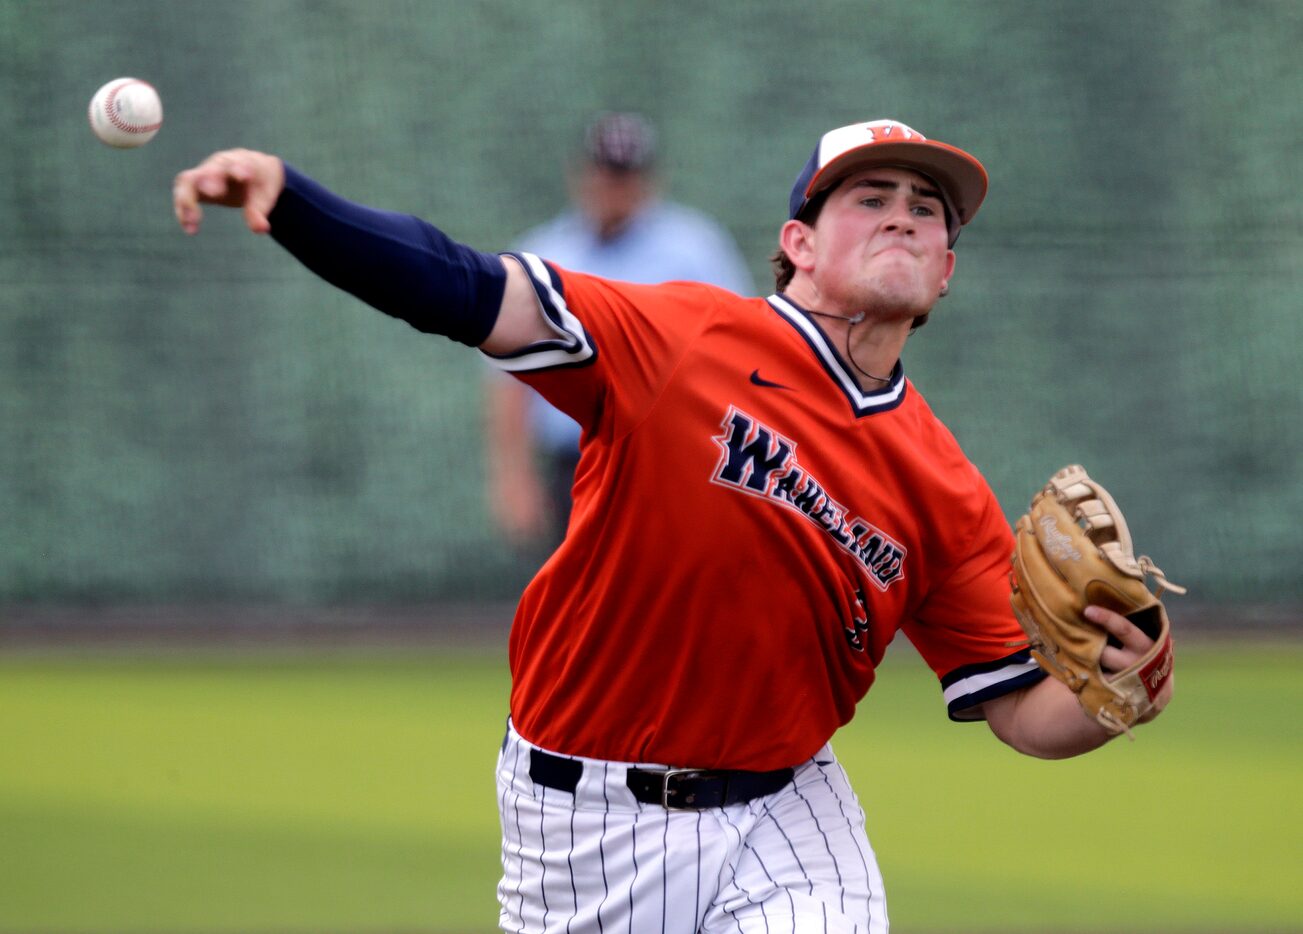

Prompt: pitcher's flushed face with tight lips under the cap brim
[{"left": 810, "top": 168, "right": 955, "bottom": 324}]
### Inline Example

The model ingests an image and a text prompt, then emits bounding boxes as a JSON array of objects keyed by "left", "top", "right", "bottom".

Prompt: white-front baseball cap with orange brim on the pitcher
[{"left": 788, "top": 120, "right": 986, "bottom": 246}]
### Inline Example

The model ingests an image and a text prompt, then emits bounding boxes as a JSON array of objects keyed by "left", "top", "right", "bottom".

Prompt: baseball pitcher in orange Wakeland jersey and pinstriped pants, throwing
[{"left": 173, "top": 120, "right": 1170, "bottom": 934}]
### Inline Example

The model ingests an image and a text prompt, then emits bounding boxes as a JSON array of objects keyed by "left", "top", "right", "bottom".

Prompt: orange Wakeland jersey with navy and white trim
[{"left": 493, "top": 254, "right": 1042, "bottom": 770}]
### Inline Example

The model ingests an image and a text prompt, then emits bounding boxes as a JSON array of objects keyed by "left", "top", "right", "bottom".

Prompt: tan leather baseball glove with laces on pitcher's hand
[{"left": 1010, "top": 464, "right": 1186, "bottom": 735}]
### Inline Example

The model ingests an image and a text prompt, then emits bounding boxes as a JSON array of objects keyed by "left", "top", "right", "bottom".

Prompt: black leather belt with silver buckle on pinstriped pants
[{"left": 529, "top": 749, "right": 794, "bottom": 810}]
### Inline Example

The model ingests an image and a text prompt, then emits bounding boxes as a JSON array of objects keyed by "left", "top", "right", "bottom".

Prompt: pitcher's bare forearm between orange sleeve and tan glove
[{"left": 985, "top": 677, "right": 1113, "bottom": 759}]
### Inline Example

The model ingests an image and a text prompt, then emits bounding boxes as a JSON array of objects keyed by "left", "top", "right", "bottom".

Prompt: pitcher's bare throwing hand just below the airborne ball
[{"left": 172, "top": 150, "right": 285, "bottom": 233}]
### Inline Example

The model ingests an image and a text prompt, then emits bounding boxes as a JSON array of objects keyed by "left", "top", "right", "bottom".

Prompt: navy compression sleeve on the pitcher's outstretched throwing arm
[{"left": 268, "top": 163, "right": 507, "bottom": 347}]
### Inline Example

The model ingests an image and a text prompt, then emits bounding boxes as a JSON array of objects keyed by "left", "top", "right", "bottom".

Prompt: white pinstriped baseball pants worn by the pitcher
[{"left": 498, "top": 728, "right": 887, "bottom": 934}]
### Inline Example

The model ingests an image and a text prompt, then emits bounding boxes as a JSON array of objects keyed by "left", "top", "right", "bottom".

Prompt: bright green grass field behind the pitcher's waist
[{"left": 0, "top": 645, "right": 1303, "bottom": 934}]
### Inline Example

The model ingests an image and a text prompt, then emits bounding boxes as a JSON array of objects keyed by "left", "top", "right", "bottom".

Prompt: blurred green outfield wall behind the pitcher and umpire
[{"left": 0, "top": 0, "right": 1303, "bottom": 604}]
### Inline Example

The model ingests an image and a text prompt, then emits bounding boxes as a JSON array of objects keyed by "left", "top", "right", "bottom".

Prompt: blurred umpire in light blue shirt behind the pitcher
[{"left": 485, "top": 112, "right": 753, "bottom": 541}]
